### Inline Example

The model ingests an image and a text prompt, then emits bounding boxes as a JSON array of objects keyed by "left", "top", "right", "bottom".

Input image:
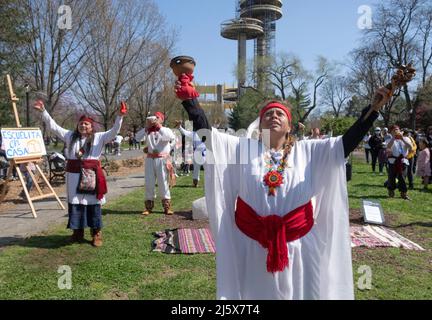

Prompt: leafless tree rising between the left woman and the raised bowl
[{"left": 76, "top": 0, "right": 172, "bottom": 128}]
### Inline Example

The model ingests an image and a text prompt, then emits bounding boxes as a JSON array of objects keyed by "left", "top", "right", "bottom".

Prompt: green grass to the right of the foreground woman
[{"left": 348, "top": 156, "right": 432, "bottom": 299}]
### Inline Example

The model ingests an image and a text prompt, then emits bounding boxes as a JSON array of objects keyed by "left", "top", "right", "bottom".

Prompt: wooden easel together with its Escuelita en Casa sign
[{"left": 0, "top": 75, "right": 65, "bottom": 218}]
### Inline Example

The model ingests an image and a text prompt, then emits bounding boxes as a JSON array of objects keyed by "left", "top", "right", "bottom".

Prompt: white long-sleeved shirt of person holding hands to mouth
[{"left": 135, "top": 127, "right": 175, "bottom": 154}]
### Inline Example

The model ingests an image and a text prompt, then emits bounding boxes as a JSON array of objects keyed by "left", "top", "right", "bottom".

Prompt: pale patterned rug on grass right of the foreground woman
[{"left": 350, "top": 225, "right": 424, "bottom": 251}]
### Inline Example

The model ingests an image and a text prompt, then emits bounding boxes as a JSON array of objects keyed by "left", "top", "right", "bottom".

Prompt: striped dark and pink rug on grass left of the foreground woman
[{"left": 152, "top": 228, "right": 216, "bottom": 254}]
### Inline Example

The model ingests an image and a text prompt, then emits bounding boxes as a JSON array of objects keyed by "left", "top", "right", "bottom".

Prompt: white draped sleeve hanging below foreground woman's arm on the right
[{"left": 306, "top": 136, "right": 354, "bottom": 300}]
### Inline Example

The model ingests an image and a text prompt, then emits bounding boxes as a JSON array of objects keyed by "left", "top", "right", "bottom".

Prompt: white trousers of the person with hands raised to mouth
[{"left": 144, "top": 158, "right": 171, "bottom": 200}]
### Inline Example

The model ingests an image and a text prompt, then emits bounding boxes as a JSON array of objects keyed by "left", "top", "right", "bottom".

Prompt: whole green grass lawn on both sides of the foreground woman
[{"left": 0, "top": 161, "right": 432, "bottom": 299}]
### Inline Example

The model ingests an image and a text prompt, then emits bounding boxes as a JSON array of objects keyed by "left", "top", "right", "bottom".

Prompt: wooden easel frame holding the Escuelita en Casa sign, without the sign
[{"left": 4, "top": 75, "right": 65, "bottom": 218}]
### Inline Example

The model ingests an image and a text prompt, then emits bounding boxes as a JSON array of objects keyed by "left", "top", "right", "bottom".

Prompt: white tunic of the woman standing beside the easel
[{"left": 42, "top": 110, "right": 123, "bottom": 205}]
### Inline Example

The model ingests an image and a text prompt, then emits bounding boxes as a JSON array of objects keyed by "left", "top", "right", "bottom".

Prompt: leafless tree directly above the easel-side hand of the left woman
[{"left": 22, "top": 0, "right": 94, "bottom": 111}]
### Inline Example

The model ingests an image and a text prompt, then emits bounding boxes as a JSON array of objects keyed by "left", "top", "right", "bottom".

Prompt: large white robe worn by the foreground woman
[{"left": 205, "top": 129, "right": 354, "bottom": 299}]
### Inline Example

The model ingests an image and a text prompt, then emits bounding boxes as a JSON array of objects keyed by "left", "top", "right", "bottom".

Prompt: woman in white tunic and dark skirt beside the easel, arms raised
[{"left": 34, "top": 100, "right": 126, "bottom": 247}]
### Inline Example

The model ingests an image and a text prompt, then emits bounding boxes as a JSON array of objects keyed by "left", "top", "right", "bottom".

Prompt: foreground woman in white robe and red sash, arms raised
[{"left": 175, "top": 75, "right": 389, "bottom": 299}]
